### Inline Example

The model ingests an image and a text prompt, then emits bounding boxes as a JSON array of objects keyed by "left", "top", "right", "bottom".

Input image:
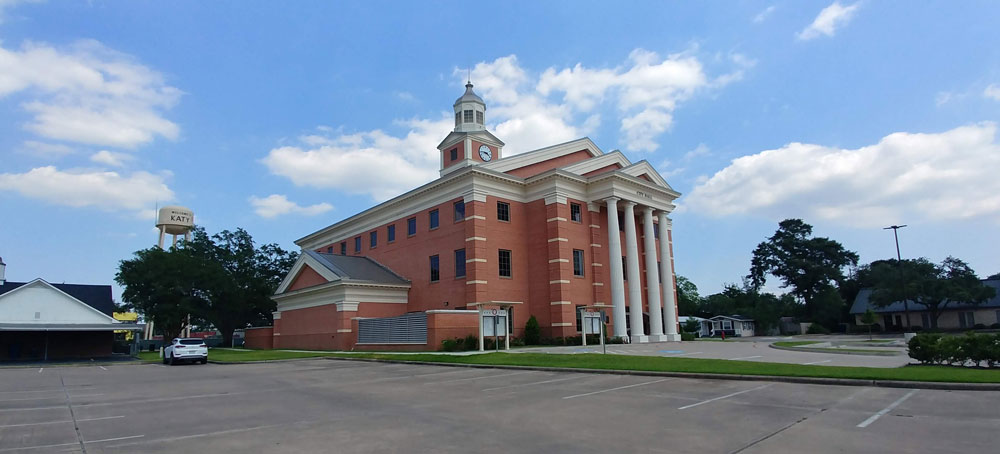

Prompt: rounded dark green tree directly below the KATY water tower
[{"left": 115, "top": 247, "right": 205, "bottom": 339}]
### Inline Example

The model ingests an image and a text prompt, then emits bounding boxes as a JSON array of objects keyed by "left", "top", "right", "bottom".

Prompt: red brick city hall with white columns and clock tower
[{"left": 258, "top": 83, "right": 680, "bottom": 350}]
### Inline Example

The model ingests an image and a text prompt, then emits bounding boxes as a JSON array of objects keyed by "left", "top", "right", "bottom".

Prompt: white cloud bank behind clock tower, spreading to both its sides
[{"left": 262, "top": 49, "right": 754, "bottom": 200}]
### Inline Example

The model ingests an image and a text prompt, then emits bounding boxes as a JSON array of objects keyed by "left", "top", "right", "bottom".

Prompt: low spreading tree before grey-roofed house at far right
[{"left": 869, "top": 257, "right": 996, "bottom": 328}]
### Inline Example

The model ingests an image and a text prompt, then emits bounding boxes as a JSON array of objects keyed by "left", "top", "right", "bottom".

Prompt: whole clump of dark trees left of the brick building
[{"left": 115, "top": 227, "right": 298, "bottom": 345}]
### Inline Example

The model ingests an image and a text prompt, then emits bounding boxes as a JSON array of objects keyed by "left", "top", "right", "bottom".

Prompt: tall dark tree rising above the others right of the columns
[{"left": 747, "top": 219, "right": 858, "bottom": 323}]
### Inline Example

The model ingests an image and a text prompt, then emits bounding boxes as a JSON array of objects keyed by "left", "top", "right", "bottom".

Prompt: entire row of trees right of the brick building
[{"left": 677, "top": 219, "right": 1000, "bottom": 333}]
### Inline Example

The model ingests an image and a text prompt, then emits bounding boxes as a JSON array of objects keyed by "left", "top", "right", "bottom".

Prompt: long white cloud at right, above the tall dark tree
[{"left": 684, "top": 123, "right": 1000, "bottom": 227}]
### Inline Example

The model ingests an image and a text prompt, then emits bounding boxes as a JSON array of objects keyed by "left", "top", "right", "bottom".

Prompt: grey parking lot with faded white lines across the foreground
[{"left": 0, "top": 359, "right": 1000, "bottom": 453}]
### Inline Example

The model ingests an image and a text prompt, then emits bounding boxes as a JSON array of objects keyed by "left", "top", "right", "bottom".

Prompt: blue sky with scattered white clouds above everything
[{"left": 0, "top": 0, "right": 1000, "bottom": 297}]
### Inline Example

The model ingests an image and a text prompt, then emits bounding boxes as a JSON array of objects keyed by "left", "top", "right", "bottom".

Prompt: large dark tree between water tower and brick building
[{"left": 184, "top": 228, "right": 298, "bottom": 345}]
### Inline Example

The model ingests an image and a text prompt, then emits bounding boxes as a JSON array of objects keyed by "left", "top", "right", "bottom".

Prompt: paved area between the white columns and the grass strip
[{"left": 516, "top": 338, "right": 910, "bottom": 367}]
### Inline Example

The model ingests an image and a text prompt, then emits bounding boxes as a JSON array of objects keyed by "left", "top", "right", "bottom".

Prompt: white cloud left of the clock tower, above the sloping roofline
[{"left": 262, "top": 116, "right": 454, "bottom": 200}]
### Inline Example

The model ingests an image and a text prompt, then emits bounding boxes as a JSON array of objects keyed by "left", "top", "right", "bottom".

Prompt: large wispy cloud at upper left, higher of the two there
[{"left": 0, "top": 40, "right": 181, "bottom": 148}]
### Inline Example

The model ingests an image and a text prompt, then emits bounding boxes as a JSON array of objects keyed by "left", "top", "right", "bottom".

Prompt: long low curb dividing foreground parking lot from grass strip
[{"left": 321, "top": 356, "right": 1000, "bottom": 391}]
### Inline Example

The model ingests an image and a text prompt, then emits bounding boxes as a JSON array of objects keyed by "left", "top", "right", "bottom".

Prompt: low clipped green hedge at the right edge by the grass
[{"left": 909, "top": 333, "right": 1000, "bottom": 367}]
